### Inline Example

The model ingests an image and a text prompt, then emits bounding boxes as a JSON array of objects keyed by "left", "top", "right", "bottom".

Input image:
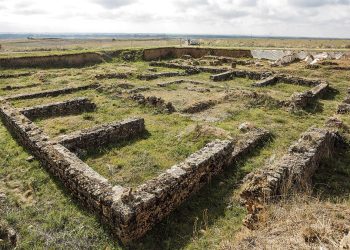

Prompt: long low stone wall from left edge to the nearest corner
[{"left": 0, "top": 103, "right": 122, "bottom": 227}]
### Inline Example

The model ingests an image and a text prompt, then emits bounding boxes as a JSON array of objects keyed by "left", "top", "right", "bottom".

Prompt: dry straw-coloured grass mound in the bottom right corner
[{"left": 224, "top": 195, "right": 350, "bottom": 250}]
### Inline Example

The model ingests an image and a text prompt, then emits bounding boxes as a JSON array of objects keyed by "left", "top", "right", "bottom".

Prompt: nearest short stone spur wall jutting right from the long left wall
[{"left": 55, "top": 118, "right": 146, "bottom": 152}]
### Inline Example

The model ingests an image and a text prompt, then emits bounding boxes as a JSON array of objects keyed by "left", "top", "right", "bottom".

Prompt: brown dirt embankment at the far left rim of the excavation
[{"left": 0, "top": 52, "right": 104, "bottom": 68}]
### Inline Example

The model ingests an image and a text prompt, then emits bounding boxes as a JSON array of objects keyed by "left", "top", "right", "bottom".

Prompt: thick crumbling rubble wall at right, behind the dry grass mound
[{"left": 240, "top": 127, "right": 341, "bottom": 228}]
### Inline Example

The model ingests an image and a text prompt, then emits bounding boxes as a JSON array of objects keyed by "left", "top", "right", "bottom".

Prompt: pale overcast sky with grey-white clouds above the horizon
[{"left": 0, "top": 0, "right": 350, "bottom": 38}]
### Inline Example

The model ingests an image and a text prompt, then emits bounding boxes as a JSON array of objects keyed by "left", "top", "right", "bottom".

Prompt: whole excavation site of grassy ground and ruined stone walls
[{"left": 0, "top": 39, "right": 350, "bottom": 249}]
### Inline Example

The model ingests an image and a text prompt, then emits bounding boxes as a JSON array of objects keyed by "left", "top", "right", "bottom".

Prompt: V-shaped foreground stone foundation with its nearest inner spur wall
[{"left": 0, "top": 99, "right": 267, "bottom": 242}]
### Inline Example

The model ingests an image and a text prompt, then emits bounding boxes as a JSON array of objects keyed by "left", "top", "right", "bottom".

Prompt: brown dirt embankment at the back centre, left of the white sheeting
[{"left": 143, "top": 47, "right": 252, "bottom": 61}]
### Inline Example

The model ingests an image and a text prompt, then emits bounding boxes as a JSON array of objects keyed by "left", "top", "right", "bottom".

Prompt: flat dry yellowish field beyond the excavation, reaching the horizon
[{"left": 0, "top": 38, "right": 350, "bottom": 58}]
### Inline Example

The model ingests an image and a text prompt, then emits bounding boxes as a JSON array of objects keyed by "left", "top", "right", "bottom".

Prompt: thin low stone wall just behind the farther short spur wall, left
[{"left": 4, "top": 83, "right": 99, "bottom": 101}]
